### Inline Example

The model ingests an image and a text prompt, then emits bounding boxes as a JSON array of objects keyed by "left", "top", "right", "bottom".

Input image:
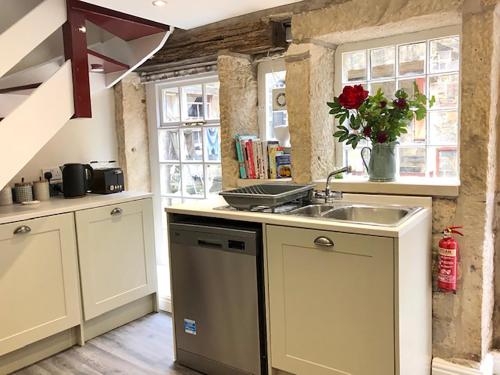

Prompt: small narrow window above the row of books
[{"left": 258, "top": 60, "right": 290, "bottom": 147}]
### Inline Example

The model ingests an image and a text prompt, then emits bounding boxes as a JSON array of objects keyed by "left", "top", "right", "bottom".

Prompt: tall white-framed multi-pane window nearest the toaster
[{"left": 158, "top": 78, "right": 222, "bottom": 207}]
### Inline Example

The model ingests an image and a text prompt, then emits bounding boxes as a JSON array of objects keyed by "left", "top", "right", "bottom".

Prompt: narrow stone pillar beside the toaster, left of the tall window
[{"left": 115, "top": 74, "right": 151, "bottom": 191}]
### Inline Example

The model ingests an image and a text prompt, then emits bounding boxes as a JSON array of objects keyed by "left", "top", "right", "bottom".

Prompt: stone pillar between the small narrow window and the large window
[{"left": 285, "top": 43, "right": 335, "bottom": 183}]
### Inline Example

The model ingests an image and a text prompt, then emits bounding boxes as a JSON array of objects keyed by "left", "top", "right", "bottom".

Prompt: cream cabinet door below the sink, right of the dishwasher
[{"left": 267, "top": 226, "right": 394, "bottom": 375}]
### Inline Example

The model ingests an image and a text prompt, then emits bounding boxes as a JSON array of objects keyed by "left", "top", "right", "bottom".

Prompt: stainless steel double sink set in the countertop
[{"left": 288, "top": 202, "right": 422, "bottom": 226}]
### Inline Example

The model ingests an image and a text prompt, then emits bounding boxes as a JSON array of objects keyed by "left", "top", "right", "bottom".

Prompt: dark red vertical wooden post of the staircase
[{"left": 63, "top": 0, "right": 92, "bottom": 118}]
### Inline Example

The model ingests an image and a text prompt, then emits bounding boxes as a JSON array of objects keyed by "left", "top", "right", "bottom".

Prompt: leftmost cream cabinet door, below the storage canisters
[{"left": 0, "top": 214, "right": 81, "bottom": 355}]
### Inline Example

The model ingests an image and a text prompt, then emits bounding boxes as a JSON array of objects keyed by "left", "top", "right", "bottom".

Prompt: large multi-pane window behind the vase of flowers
[{"left": 335, "top": 29, "right": 460, "bottom": 178}]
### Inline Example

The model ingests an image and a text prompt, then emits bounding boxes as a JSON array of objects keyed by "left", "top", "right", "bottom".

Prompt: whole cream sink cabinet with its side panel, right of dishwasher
[{"left": 266, "top": 225, "right": 431, "bottom": 375}]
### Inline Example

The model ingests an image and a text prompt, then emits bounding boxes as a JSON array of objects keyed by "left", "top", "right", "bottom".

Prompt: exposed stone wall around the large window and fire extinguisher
[{"left": 287, "top": 0, "right": 500, "bottom": 368}]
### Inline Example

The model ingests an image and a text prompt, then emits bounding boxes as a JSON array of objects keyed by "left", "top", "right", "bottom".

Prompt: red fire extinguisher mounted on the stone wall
[{"left": 438, "top": 227, "right": 463, "bottom": 293}]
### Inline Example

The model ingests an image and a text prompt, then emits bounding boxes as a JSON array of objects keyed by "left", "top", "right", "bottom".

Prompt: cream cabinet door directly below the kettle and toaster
[{"left": 76, "top": 199, "right": 156, "bottom": 320}]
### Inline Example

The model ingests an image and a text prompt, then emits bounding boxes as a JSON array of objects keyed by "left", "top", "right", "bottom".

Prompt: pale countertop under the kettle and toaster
[{"left": 0, "top": 191, "right": 152, "bottom": 224}]
